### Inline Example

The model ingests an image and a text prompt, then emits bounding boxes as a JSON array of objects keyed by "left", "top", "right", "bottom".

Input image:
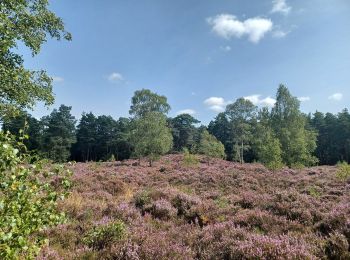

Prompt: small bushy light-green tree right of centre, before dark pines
[{"left": 198, "top": 130, "right": 225, "bottom": 165}]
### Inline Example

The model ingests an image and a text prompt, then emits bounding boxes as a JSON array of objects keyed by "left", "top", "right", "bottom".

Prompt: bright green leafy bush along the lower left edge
[{"left": 0, "top": 132, "right": 71, "bottom": 259}]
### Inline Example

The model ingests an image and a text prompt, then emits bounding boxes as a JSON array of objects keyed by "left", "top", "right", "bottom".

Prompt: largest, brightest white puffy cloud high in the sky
[{"left": 207, "top": 14, "right": 273, "bottom": 43}]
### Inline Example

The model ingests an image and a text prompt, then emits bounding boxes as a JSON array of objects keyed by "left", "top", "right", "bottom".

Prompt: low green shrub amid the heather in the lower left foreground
[{"left": 83, "top": 220, "right": 127, "bottom": 250}]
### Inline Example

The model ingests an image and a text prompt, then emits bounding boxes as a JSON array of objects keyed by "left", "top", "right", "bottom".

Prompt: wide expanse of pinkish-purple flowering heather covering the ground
[{"left": 38, "top": 155, "right": 350, "bottom": 260}]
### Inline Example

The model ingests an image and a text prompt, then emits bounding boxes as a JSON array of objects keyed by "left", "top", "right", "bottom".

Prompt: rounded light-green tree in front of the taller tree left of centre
[{"left": 130, "top": 112, "right": 173, "bottom": 166}]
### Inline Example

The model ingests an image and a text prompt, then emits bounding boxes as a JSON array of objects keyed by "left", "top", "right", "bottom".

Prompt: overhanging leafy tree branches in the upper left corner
[{"left": 0, "top": 0, "right": 71, "bottom": 116}]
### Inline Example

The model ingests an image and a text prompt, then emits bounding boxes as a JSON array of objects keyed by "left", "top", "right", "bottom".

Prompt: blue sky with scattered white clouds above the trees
[{"left": 18, "top": 0, "right": 350, "bottom": 124}]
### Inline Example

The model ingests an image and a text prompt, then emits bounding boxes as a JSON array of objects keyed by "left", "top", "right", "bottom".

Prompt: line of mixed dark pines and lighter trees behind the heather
[{"left": 2, "top": 85, "right": 350, "bottom": 168}]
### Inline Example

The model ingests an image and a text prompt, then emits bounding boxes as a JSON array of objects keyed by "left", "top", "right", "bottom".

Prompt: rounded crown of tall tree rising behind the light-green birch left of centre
[{"left": 129, "top": 89, "right": 170, "bottom": 118}]
